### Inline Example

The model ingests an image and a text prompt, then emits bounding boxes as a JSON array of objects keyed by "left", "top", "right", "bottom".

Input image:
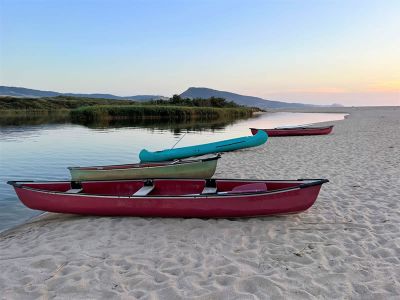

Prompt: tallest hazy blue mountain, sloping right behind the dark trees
[{"left": 180, "top": 87, "right": 313, "bottom": 109}]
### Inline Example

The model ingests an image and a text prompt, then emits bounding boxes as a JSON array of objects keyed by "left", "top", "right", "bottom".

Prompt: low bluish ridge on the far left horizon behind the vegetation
[{"left": 0, "top": 86, "right": 168, "bottom": 101}]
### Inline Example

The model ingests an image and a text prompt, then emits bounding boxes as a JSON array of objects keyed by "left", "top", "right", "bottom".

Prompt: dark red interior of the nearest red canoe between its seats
[{"left": 21, "top": 179, "right": 303, "bottom": 196}]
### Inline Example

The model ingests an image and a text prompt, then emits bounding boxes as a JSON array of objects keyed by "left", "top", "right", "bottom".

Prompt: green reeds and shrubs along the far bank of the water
[{"left": 0, "top": 95, "right": 259, "bottom": 125}]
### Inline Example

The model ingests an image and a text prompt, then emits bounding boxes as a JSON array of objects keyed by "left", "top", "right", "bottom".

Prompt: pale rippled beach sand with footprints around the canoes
[{"left": 0, "top": 107, "right": 400, "bottom": 299}]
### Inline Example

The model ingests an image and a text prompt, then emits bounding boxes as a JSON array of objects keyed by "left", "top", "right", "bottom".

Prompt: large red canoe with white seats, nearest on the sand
[{"left": 8, "top": 179, "right": 328, "bottom": 218}]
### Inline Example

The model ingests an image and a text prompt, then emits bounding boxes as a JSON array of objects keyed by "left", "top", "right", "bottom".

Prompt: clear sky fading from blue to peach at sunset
[{"left": 0, "top": 0, "right": 400, "bottom": 106}]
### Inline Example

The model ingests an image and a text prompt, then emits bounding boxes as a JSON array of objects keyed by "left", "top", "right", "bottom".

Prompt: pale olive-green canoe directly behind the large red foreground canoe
[{"left": 68, "top": 156, "right": 219, "bottom": 181}]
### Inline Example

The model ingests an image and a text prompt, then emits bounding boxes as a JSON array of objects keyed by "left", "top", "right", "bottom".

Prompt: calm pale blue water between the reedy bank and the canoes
[{"left": 0, "top": 112, "right": 345, "bottom": 231}]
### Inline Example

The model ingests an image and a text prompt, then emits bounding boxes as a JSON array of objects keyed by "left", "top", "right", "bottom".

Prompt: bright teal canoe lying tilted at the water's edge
[{"left": 139, "top": 130, "right": 268, "bottom": 162}]
